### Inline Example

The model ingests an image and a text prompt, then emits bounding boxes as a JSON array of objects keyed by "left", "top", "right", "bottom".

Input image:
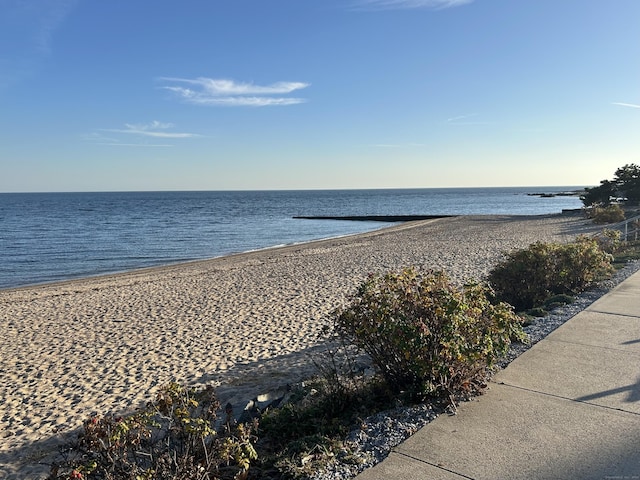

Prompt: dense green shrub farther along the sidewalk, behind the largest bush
[{"left": 488, "top": 237, "right": 612, "bottom": 311}]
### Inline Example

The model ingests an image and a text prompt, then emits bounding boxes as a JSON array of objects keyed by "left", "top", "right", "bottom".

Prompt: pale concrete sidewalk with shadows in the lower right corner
[{"left": 357, "top": 272, "right": 640, "bottom": 480}]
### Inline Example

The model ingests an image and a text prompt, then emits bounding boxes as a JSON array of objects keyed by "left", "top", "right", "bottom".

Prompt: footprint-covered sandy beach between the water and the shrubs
[{"left": 0, "top": 214, "right": 597, "bottom": 478}]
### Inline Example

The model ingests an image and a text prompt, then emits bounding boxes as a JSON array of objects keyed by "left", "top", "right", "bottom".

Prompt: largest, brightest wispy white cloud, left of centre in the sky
[{"left": 160, "top": 77, "right": 309, "bottom": 107}]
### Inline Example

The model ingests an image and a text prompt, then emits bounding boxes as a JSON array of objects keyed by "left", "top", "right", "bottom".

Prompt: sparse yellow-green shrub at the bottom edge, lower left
[{"left": 48, "top": 383, "right": 257, "bottom": 480}]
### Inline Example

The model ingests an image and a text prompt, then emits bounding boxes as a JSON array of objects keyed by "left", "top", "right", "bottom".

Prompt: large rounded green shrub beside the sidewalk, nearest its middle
[{"left": 334, "top": 268, "right": 524, "bottom": 396}]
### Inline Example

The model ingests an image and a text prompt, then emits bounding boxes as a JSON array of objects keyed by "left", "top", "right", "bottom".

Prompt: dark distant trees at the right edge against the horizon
[{"left": 580, "top": 163, "right": 640, "bottom": 207}]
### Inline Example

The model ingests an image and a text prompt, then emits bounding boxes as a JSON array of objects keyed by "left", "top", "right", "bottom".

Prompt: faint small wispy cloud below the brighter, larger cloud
[{"left": 85, "top": 120, "right": 202, "bottom": 147}]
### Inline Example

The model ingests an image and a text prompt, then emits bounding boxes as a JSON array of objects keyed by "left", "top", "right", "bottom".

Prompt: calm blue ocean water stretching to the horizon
[{"left": 0, "top": 187, "right": 581, "bottom": 288}]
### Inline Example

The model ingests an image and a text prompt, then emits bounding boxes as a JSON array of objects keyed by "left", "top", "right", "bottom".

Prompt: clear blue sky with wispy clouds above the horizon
[{"left": 0, "top": 0, "right": 640, "bottom": 192}]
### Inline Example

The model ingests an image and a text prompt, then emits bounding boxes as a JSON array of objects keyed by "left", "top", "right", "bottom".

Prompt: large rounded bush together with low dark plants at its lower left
[{"left": 258, "top": 268, "right": 524, "bottom": 478}]
